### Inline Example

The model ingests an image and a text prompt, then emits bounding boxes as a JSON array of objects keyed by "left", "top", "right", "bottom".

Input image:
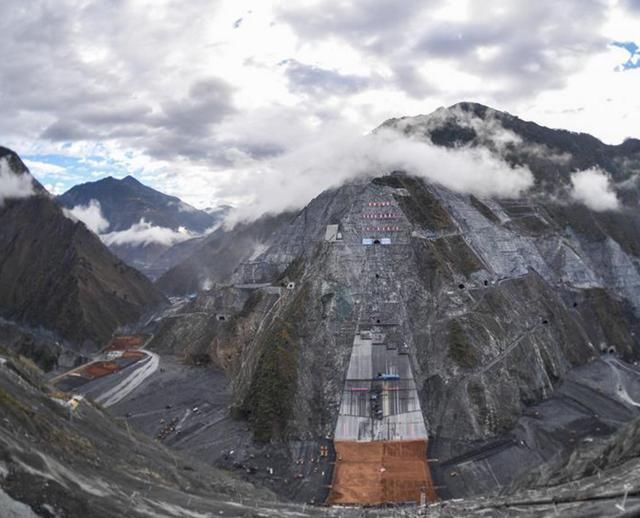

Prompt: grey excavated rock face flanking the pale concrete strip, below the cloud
[{"left": 231, "top": 175, "right": 640, "bottom": 432}]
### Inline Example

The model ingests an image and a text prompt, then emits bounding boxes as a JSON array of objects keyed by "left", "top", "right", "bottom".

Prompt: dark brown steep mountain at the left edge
[{"left": 0, "top": 148, "right": 165, "bottom": 366}]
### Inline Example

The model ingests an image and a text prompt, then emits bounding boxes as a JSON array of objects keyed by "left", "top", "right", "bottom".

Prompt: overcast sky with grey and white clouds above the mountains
[{"left": 0, "top": 0, "right": 640, "bottom": 211}]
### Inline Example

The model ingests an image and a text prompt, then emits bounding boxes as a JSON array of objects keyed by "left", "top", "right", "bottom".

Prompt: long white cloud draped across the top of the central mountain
[{"left": 229, "top": 127, "right": 533, "bottom": 224}]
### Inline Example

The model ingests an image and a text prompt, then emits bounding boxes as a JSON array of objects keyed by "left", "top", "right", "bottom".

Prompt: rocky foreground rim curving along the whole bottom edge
[{"left": 0, "top": 349, "right": 640, "bottom": 518}]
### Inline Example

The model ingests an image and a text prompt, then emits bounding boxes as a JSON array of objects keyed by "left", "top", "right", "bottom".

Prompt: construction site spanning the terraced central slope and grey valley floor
[{"left": 28, "top": 179, "right": 640, "bottom": 513}]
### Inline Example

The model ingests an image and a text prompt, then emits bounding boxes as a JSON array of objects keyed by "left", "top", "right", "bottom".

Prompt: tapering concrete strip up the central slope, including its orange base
[{"left": 328, "top": 195, "right": 436, "bottom": 505}]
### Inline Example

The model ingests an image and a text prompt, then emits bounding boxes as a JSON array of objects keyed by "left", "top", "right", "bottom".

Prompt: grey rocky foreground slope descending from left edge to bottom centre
[{"left": 0, "top": 350, "right": 287, "bottom": 517}]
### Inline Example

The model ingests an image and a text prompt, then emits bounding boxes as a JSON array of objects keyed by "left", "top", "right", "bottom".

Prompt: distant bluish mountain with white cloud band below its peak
[{"left": 57, "top": 176, "right": 229, "bottom": 278}]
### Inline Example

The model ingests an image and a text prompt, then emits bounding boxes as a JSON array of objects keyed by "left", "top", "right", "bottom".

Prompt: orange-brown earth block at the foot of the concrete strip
[{"left": 327, "top": 440, "right": 438, "bottom": 505}]
